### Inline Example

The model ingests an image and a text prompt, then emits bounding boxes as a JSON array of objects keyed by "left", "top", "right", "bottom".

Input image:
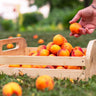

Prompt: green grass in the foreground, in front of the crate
[{"left": 0, "top": 73, "right": 96, "bottom": 96}]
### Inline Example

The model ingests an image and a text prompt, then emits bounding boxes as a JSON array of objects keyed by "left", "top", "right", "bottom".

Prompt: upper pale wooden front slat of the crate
[{"left": 0, "top": 56, "right": 85, "bottom": 66}]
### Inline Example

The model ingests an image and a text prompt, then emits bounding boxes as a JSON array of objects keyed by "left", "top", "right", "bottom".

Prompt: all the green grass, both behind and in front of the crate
[{"left": 0, "top": 30, "right": 96, "bottom": 96}]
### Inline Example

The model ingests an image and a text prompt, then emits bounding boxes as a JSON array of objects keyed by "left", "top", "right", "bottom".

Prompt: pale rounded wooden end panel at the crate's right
[{"left": 85, "top": 39, "right": 96, "bottom": 78}]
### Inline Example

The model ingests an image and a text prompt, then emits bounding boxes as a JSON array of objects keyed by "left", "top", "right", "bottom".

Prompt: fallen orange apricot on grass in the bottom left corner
[{"left": 3, "top": 82, "right": 22, "bottom": 96}]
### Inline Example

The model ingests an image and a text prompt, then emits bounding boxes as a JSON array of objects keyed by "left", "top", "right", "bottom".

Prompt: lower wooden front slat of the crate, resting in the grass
[{"left": 0, "top": 66, "right": 85, "bottom": 79}]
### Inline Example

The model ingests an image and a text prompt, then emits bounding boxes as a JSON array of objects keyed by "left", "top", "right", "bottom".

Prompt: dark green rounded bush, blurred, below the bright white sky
[{"left": 23, "top": 12, "right": 43, "bottom": 27}]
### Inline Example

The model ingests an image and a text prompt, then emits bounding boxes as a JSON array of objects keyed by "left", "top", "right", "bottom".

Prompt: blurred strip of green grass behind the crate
[{"left": 0, "top": 30, "right": 96, "bottom": 47}]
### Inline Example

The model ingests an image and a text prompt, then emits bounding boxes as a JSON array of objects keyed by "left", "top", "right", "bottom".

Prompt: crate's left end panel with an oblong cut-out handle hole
[{"left": 0, "top": 37, "right": 27, "bottom": 55}]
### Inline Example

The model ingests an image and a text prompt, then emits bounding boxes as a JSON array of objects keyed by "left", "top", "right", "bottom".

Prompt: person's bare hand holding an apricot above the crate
[{"left": 69, "top": 0, "right": 96, "bottom": 37}]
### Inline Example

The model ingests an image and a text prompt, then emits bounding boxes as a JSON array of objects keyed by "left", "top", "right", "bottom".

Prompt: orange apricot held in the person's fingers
[{"left": 69, "top": 23, "right": 82, "bottom": 34}]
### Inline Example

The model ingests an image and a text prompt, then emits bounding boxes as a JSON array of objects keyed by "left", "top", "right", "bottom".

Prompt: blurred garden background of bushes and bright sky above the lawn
[{"left": 0, "top": 0, "right": 92, "bottom": 32}]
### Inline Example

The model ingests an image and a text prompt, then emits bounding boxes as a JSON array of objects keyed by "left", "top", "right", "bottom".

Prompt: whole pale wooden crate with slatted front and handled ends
[{"left": 0, "top": 37, "right": 96, "bottom": 80}]
